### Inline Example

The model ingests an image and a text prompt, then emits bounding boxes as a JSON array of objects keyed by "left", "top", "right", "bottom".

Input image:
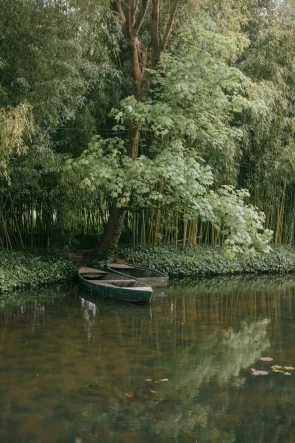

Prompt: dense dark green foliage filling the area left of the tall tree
[{"left": 0, "top": 0, "right": 121, "bottom": 247}]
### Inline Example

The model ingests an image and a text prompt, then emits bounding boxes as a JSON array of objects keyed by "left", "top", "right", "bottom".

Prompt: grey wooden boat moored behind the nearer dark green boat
[{"left": 107, "top": 262, "right": 169, "bottom": 287}]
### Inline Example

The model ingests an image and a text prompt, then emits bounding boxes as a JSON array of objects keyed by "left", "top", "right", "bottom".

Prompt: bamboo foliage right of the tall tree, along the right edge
[{"left": 237, "top": 1, "right": 295, "bottom": 244}]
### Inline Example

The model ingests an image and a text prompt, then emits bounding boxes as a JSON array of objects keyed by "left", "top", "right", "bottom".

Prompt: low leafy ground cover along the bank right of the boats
[{"left": 112, "top": 245, "right": 295, "bottom": 278}]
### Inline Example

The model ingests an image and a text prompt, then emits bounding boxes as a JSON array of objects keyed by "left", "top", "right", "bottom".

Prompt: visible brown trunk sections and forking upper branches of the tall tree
[{"left": 93, "top": 0, "right": 183, "bottom": 254}]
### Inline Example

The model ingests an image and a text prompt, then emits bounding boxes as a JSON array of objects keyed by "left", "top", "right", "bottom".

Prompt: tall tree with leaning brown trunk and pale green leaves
[{"left": 68, "top": 2, "right": 269, "bottom": 253}]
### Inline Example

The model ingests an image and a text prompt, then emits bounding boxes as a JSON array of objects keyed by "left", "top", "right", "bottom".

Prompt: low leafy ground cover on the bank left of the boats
[{"left": 0, "top": 251, "right": 75, "bottom": 292}]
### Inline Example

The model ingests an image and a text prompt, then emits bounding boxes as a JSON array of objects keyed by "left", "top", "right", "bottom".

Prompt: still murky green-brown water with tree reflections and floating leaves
[{"left": 0, "top": 276, "right": 295, "bottom": 443}]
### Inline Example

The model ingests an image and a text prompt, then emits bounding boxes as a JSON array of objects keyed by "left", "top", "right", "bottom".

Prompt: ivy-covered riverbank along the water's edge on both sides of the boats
[{"left": 0, "top": 245, "right": 295, "bottom": 293}]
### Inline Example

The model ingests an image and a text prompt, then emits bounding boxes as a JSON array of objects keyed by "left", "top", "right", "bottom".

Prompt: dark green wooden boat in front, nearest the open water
[{"left": 78, "top": 266, "right": 153, "bottom": 303}]
